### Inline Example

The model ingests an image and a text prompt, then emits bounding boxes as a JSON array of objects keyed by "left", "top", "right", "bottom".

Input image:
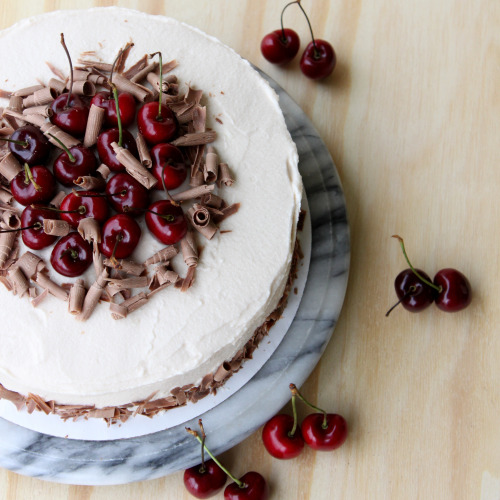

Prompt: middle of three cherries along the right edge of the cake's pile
[{"left": 151, "top": 143, "right": 188, "bottom": 193}]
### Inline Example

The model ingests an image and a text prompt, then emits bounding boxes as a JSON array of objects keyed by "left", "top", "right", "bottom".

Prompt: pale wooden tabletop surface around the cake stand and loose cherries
[{"left": 0, "top": 0, "right": 500, "bottom": 500}]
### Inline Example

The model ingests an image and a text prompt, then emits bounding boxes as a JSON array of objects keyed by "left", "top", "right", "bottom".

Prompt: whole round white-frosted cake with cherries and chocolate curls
[{"left": 0, "top": 8, "right": 301, "bottom": 421}]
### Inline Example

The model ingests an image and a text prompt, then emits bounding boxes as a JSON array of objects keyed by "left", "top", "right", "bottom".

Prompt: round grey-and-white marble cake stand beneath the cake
[{"left": 0, "top": 75, "right": 349, "bottom": 485}]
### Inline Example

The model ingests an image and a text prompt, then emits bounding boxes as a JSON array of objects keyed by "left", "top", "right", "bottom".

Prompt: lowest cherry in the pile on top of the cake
[{"left": 50, "top": 231, "right": 92, "bottom": 278}]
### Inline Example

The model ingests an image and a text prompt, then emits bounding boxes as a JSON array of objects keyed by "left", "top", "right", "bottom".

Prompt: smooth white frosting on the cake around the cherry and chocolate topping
[{"left": 0, "top": 8, "right": 302, "bottom": 406}]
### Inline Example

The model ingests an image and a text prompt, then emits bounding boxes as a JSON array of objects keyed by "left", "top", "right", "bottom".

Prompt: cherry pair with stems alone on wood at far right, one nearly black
[{"left": 386, "top": 235, "right": 472, "bottom": 316}]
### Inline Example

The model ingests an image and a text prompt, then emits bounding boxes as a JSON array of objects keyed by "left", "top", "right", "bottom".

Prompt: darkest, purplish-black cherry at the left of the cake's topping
[{"left": 5, "top": 125, "right": 50, "bottom": 166}]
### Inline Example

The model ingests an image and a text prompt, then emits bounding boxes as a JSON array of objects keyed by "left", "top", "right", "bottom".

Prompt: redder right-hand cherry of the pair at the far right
[{"left": 434, "top": 268, "right": 472, "bottom": 312}]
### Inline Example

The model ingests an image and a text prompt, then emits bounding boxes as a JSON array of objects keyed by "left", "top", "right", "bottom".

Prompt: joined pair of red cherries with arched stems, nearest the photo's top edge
[{"left": 260, "top": 0, "right": 337, "bottom": 80}]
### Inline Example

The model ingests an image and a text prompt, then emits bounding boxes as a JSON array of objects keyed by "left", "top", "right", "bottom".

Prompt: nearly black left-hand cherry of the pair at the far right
[{"left": 394, "top": 269, "right": 436, "bottom": 312}]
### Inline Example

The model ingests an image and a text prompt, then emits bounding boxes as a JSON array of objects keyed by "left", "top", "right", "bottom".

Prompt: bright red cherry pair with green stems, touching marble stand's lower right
[{"left": 262, "top": 384, "right": 347, "bottom": 460}]
